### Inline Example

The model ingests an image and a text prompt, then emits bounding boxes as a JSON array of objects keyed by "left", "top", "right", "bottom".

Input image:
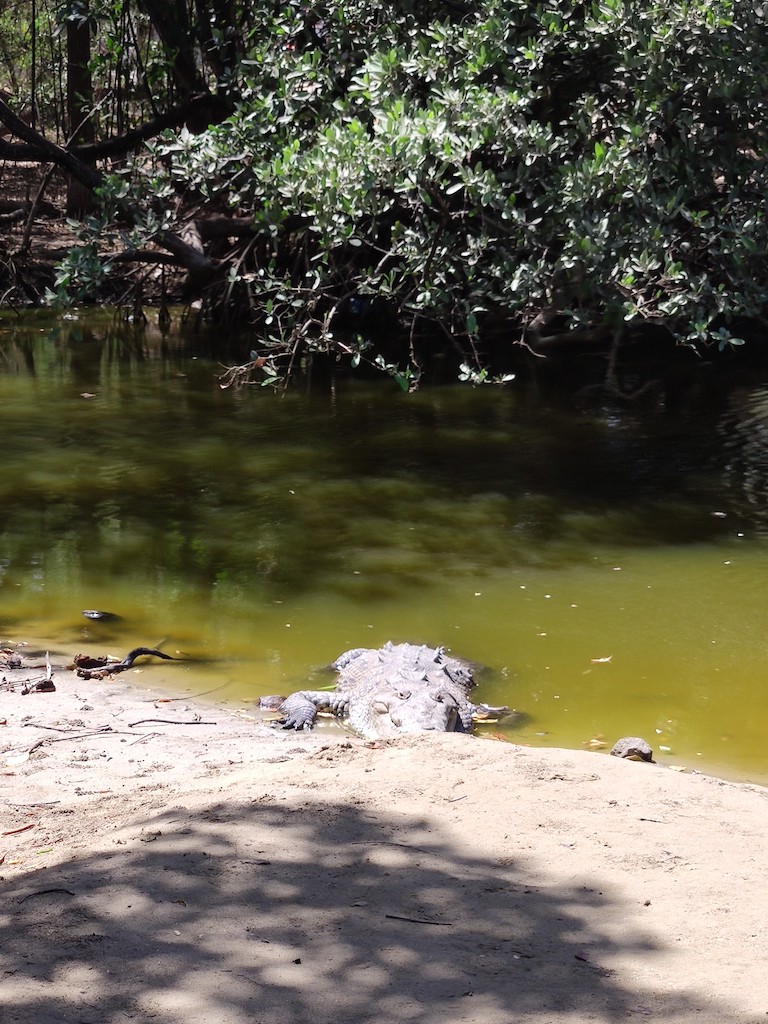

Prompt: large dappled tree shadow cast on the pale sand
[{"left": 0, "top": 801, "right": 738, "bottom": 1024}]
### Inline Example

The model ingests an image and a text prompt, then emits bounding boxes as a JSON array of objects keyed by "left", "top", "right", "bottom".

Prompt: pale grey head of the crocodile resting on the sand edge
[{"left": 349, "top": 688, "right": 460, "bottom": 739}]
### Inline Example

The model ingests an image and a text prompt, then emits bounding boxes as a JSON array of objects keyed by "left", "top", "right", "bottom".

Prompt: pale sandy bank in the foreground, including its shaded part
[{"left": 0, "top": 655, "right": 768, "bottom": 1024}]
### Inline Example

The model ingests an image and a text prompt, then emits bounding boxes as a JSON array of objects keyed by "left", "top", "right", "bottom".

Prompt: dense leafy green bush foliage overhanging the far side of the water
[{"left": 6, "top": 0, "right": 768, "bottom": 386}]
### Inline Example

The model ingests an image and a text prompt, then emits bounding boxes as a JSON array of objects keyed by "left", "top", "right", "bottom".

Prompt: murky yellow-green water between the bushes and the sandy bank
[{"left": 0, "top": 317, "right": 768, "bottom": 782}]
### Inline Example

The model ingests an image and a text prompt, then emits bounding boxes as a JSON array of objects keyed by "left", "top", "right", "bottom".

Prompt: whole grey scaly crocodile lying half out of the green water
[{"left": 279, "top": 641, "right": 510, "bottom": 739}]
